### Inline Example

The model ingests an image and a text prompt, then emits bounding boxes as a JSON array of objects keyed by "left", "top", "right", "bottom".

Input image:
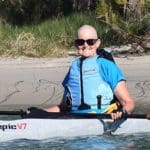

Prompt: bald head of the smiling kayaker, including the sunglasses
[{"left": 75, "top": 25, "right": 101, "bottom": 57}]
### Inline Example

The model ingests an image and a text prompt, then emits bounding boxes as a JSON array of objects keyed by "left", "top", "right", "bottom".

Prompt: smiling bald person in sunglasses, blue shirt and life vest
[{"left": 46, "top": 25, "right": 135, "bottom": 120}]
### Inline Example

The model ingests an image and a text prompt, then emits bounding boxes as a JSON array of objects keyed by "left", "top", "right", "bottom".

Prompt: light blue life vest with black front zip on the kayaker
[{"left": 66, "top": 55, "right": 113, "bottom": 113}]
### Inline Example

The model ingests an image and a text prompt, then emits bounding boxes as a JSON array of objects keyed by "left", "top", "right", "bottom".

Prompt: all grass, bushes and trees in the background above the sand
[{"left": 0, "top": 0, "right": 150, "bottom": 57}]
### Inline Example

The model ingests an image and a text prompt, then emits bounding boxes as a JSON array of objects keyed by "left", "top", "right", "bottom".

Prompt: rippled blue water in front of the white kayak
[{"left": 0, "top": 134, "right": 150, "bottom": 150}]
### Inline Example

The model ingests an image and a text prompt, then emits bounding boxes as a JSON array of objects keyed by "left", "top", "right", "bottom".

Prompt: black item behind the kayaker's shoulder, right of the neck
[{"left": 96, "top": 49, "right": 115, "bottom": 63}]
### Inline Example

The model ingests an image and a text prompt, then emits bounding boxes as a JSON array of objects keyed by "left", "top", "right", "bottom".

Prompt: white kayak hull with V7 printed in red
[{"left": 0, "top": 118, "right": 150, "bottom": 142}]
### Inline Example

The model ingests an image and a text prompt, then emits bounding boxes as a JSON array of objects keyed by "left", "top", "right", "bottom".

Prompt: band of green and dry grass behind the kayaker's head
[{"left": 0, "top": 13, "right": 149, "bottom": 57}]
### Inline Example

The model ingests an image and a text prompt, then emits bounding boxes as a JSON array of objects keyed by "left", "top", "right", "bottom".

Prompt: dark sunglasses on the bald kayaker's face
[{"left": 75, "top": 39, "right": 98, "bottom": 46}]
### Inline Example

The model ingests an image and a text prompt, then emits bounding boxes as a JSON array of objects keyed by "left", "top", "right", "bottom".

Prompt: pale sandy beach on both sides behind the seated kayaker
[{"left": 0, "top": 55, "right": 150, "bottom": 109}]
